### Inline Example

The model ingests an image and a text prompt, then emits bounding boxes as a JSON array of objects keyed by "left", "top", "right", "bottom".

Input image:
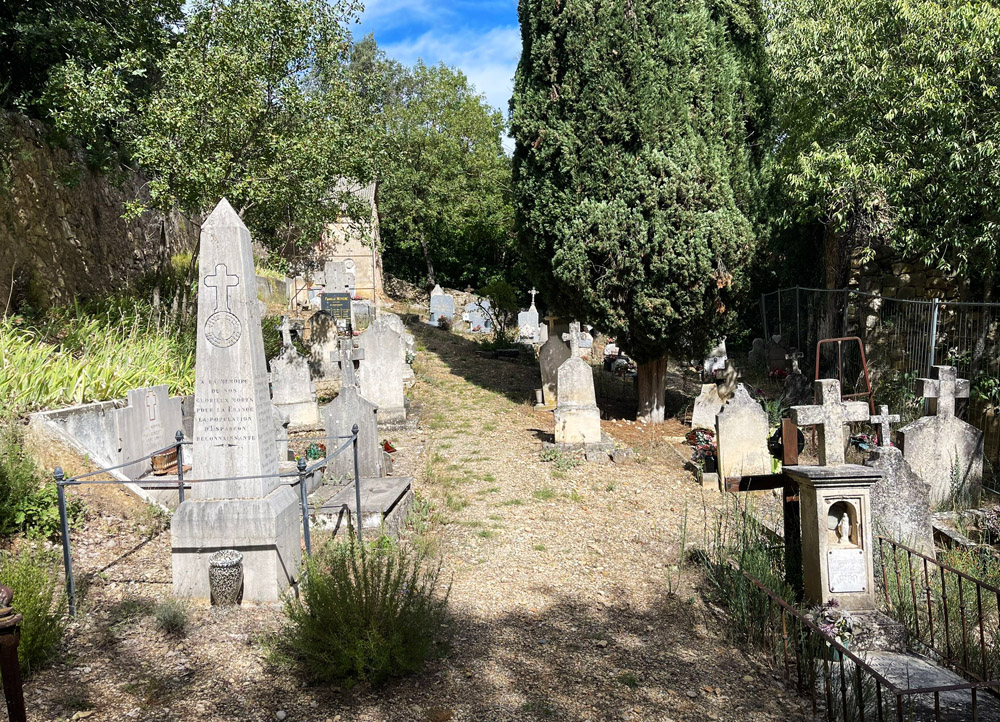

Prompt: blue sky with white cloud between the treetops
[{"left": 351, "top": 0, "right": 521, "bottom": 118}]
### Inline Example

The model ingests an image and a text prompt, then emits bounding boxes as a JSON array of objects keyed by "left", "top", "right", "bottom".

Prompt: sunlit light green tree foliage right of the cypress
[{"left": 770, "top": 0, "right": 1000, "bottom": 288}]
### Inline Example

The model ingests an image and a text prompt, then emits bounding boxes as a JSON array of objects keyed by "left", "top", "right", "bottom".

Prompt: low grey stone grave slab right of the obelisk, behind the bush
[{"left": 313, "top": 476, "right": 413, "bottom": 537}]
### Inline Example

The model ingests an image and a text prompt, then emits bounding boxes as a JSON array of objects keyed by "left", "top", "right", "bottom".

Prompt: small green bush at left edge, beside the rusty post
[{"left": 0, "top": 546, "right": 66, "bottom": 674}]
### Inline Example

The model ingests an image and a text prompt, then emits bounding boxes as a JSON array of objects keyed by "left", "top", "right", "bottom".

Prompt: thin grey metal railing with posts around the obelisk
[{"left": 52, "top": 424, "right": 361, "bottom": 616}]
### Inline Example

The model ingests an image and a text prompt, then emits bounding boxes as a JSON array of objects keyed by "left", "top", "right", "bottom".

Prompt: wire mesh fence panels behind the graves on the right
[{"left": 760, "top": 287, "right": 1000, "bottom": 490}]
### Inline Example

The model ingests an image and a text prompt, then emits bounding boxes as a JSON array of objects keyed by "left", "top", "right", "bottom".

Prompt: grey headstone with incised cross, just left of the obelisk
[{"left": 114, "top": 386, "right": 183, "bottom": 479}]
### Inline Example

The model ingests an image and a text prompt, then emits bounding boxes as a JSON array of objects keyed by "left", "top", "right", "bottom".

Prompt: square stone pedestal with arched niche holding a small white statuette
[{"left": 783, "top": 464, "right": 882, "bottom": 611}]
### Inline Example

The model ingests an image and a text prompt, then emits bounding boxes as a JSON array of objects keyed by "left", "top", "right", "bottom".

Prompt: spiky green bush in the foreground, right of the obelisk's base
[{"left": 275, "top": 537, "right": 449, "bottom": 687}]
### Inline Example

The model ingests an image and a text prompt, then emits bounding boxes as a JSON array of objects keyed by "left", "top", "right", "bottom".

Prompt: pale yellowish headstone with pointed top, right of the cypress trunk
[{"left": 715, "top": 384, "right": 771, "bottom": 479}]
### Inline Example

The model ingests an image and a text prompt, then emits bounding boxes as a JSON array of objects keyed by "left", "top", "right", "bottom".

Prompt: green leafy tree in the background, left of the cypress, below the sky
[{"left": 351, "top": 37, "right": 514, "bottom": 285}]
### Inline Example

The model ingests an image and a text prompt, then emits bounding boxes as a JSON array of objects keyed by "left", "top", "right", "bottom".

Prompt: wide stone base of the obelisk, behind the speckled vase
[{"left": 170, "top": 485, "right": 302, "bottom": 602}]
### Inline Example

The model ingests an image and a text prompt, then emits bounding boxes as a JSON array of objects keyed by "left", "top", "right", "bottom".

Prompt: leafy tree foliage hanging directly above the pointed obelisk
[{"left": 38, "top": 0, "right": 374, "bottom": 246}]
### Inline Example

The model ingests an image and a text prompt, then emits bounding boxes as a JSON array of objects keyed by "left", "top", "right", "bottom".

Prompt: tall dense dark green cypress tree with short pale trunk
[{"left": 511, "top": 0, "right": 766, "bottom": 422}]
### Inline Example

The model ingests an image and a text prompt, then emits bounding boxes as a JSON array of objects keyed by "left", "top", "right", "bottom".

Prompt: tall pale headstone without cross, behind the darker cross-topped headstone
[{"left": 358, "top": 318, "right": 406, "bottom": 426}]
